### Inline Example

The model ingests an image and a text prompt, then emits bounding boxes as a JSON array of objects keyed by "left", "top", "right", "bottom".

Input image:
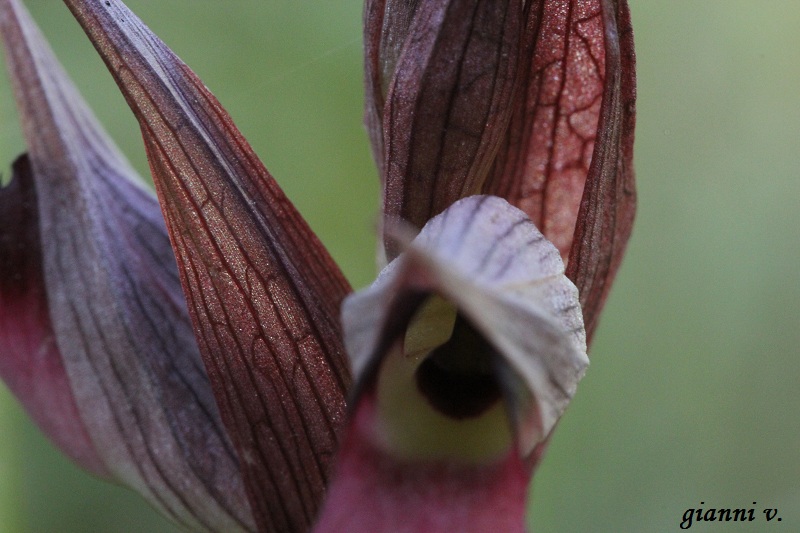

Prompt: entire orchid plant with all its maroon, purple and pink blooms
[{"left": 0, "top": 0, "right": 635, "bottom": 533}]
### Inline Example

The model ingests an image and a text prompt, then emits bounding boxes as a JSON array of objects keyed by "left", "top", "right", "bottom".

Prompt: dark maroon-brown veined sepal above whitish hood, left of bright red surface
[{"left": 366, "top": 0, "right": 524, "bottom": 258}]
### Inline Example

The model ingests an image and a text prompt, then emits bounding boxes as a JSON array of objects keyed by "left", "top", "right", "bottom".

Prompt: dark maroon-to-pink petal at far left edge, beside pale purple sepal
[{"left": 0, "top": 157, "right": 109, "bottom": 477}]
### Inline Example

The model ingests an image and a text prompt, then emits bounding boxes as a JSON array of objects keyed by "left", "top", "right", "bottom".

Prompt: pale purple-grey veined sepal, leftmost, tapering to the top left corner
[{"left": 0, "top": 0, "right": 254, "bottom": 531}]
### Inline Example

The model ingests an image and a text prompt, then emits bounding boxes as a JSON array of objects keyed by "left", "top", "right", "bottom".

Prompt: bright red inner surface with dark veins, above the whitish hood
[{"left": 484, "top": 0, "right": 605, "bottom": 259}]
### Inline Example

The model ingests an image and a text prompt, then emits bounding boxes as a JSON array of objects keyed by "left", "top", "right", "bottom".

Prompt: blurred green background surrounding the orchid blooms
[{"left": 0, "top": 0, "right": 800, "bottom": 533}]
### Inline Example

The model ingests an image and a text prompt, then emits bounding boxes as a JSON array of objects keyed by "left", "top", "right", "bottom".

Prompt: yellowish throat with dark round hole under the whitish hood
[{"left": 373, "top": 293, "right": 513, "bottom": 464}]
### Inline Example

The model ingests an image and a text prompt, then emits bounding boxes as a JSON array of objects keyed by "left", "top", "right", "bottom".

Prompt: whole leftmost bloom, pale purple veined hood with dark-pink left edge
[{"left": 0, "top": 0, "right": 255, "bottom": 531}]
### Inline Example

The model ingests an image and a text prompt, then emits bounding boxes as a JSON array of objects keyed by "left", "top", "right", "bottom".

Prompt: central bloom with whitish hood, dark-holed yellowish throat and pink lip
[{"left": 318, "top": 196, "right": 589, "bottom": 533}]
